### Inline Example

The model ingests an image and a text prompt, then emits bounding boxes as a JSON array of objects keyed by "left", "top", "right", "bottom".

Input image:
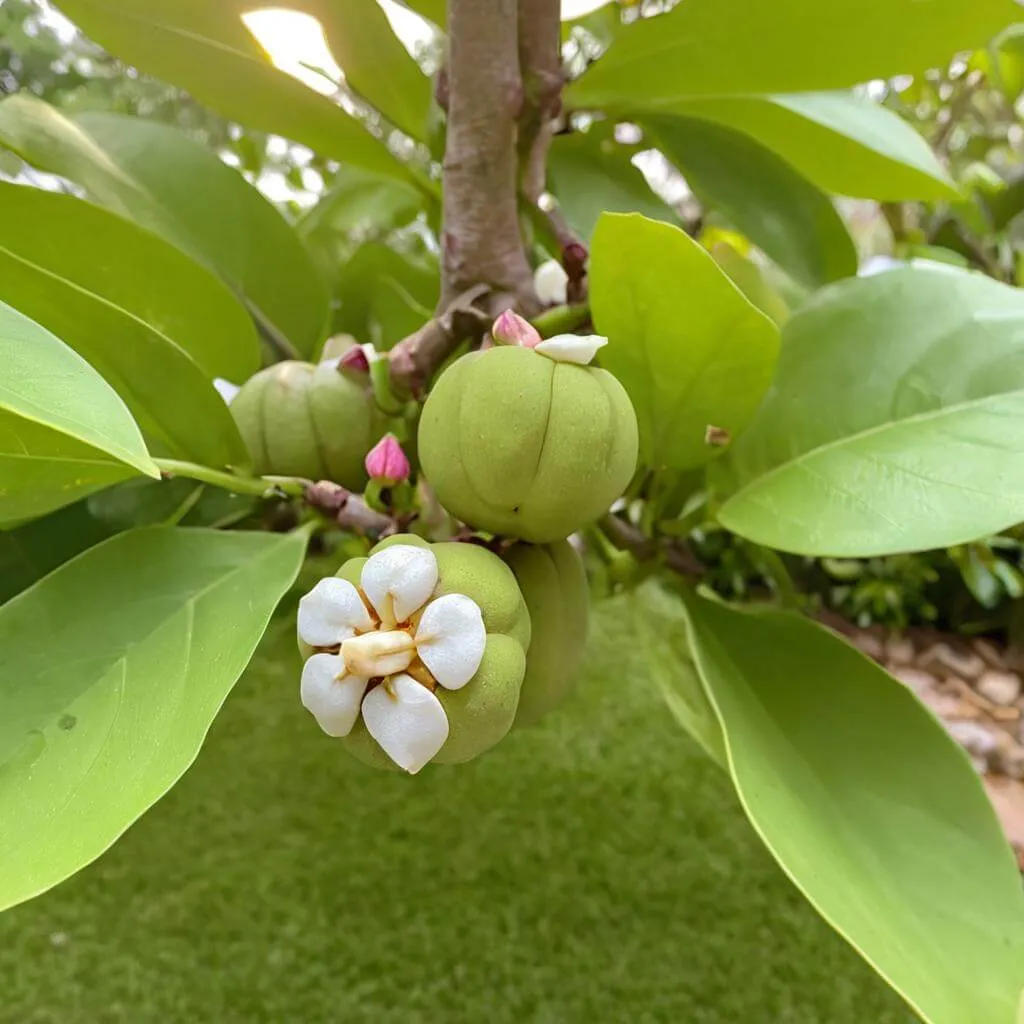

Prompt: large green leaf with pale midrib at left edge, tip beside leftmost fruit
[{"left": 0, "top": 184, "right": 248, "bottom": 466}]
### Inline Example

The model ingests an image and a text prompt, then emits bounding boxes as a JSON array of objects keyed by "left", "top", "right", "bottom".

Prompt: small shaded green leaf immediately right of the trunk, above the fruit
[{"left": 548, "top": 131, "right": 679, "bottom": 239}]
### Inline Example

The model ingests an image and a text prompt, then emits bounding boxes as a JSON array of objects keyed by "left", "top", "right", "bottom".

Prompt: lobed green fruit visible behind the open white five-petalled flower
[{"left": 337, "top": 534, "right": 530, "bottom": 769}]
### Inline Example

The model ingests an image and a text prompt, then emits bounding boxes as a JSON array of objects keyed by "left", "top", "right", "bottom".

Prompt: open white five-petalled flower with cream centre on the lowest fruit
[{"left": 298, "top": 544, "right": 487, "bottom": 774}]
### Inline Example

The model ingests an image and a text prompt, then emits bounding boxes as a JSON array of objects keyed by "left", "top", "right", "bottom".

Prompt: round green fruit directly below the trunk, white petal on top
[{"left": 419, "top": 346, "right": 638, "bottom": 544}]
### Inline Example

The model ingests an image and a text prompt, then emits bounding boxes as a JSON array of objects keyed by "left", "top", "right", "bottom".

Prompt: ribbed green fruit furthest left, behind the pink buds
[{"left": 230, "top": 360, "right": 386, "bottom": 490}]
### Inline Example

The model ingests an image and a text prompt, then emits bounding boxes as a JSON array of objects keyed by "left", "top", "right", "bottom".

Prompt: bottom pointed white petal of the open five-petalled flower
[{"left": 362, "top": 675, "right": 447, "bottom": 775}]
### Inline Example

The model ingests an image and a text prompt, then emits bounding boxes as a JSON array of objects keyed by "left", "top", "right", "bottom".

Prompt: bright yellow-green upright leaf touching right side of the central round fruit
[{"left": 590, "top": 214, "right": 778, "bottom": 469}]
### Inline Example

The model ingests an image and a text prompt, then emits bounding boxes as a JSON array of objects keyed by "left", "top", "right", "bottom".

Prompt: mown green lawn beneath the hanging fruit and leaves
[{"left": 0, "top": 598, "right": 912, "bottom": 1024}]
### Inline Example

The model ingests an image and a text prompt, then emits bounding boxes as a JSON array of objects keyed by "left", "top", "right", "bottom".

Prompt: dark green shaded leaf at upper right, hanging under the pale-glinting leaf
[{"left": 643, "top": 118, "right": 857, "bottom": 289}]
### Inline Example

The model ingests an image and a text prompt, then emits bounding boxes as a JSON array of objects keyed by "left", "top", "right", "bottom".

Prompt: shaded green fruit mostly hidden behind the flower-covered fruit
[{"left": 505, "top": 541, "right": 590, "bottom": 726}]
